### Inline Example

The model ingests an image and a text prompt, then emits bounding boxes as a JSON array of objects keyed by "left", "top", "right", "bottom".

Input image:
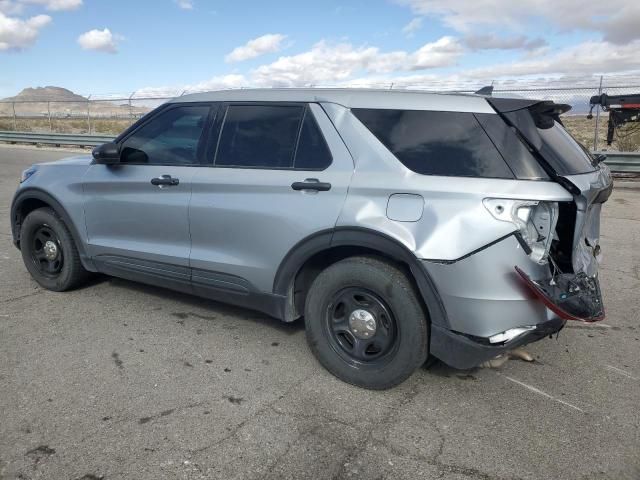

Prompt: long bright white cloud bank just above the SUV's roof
[{"left": 139, "top": 29, "right": 640, "bottom": 94}]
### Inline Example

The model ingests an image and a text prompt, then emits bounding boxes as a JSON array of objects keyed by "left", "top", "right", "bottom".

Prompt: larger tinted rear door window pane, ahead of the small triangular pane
[{"left": 215, "top": 105, "right": 304, "bottom": 168}]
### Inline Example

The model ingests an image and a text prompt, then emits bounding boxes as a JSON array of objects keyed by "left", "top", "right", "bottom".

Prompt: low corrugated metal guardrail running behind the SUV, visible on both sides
[{"left": 0, "top": 131, "right": 640, "bottom": 174}]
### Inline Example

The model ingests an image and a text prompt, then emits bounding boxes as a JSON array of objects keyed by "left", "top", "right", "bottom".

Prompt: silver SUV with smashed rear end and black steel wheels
[{"left": 11, "top": 89, "right": 612, "bottom": 389}]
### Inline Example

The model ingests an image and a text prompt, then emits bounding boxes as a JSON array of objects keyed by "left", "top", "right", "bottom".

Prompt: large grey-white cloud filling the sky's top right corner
[{"left": 396, "top": 0, "right": 640, "bottom": 43}]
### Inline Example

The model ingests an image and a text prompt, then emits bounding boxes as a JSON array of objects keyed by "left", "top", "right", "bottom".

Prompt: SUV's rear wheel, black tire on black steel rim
[{"left": 305, "top": 257, "right": 429, "bottom": 390}]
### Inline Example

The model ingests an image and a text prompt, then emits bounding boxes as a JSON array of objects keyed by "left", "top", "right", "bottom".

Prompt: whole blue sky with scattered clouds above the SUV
[{"left": 0, "top": 0, "right": 640, "bottom": 97}]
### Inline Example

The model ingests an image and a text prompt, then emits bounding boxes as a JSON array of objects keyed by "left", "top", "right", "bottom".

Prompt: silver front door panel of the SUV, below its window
[{"left": 83, "top": 165, "right": 196, "bottom": 267}]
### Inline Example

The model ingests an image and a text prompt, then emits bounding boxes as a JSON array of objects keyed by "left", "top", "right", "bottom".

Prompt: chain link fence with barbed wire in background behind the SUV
[{"left": 0, "top": 76, "right": 640, "bottom": 152}]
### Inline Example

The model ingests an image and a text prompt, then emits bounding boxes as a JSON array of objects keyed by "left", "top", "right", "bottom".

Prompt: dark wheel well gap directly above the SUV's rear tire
[{"left": 291, "top": 245, "right": 428, "bottom": 320}]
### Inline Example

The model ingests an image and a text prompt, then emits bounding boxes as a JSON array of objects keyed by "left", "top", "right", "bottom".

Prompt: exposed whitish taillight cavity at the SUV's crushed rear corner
[{"left": 482, "top": 198, "right": 558, "bottom": 264}]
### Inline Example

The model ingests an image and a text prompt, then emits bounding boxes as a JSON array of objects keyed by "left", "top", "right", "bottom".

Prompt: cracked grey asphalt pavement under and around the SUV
[{"left": 0, "top": 146, "right": 640, "bottom": 480}]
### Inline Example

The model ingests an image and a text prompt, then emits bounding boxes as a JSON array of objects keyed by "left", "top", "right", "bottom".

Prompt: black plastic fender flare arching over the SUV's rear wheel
[{"left": 273, "top": 227, "right": 449, "bottom": 328}]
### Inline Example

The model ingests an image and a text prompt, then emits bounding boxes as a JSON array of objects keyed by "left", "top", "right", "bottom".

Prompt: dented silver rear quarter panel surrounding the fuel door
[{"left": 323, "top": 104, "right": 573, "bottom": 260}]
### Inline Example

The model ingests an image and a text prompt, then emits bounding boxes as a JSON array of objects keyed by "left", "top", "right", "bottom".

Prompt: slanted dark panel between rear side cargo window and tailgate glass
[{"left": 475, "top": 113, "right": 549, "bottom": 180}]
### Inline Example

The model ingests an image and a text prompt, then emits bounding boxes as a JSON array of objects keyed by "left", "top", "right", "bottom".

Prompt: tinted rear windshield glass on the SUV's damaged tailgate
[{"left": 505, "top": 109, "right": 596, "bottom": 175}]
